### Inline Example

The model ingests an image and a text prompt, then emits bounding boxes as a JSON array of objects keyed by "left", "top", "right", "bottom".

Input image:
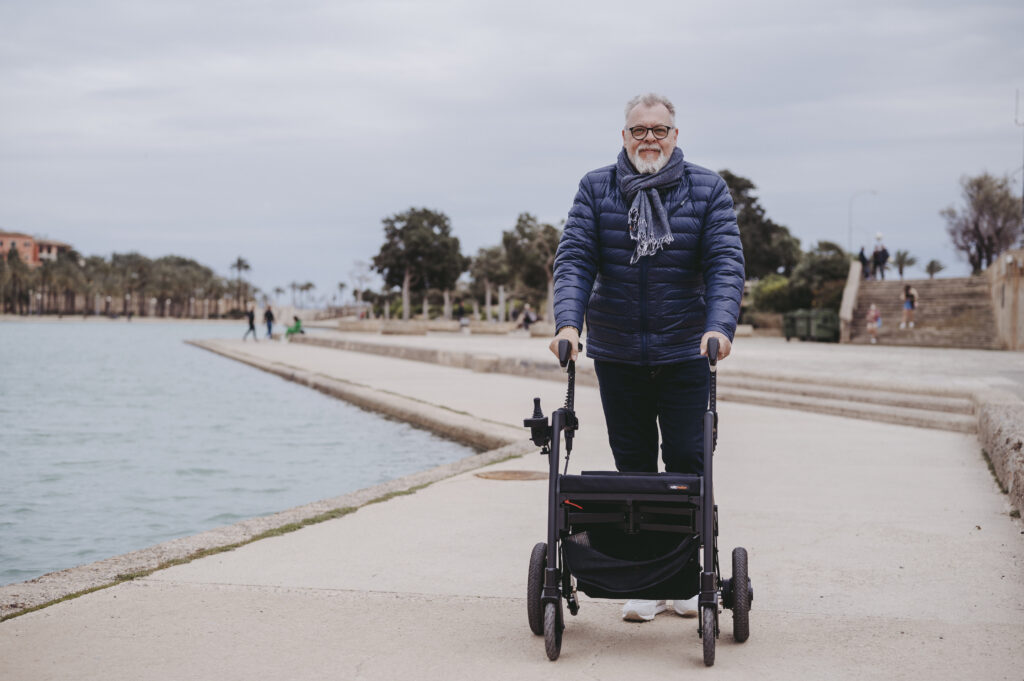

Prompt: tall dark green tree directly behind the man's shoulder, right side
[{"left": 719, "top": 170, "right": 801, "bottom": 279}]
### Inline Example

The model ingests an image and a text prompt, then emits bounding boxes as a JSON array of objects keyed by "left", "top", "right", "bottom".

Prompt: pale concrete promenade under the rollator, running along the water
[{"left": 0, "top": 336, "right": 1024, "bottom": 681}]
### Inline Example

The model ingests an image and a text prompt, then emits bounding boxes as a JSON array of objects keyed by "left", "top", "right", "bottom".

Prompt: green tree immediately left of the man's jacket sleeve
[{"left": 502, "top": 213, "right": 562, "bottom": 320}]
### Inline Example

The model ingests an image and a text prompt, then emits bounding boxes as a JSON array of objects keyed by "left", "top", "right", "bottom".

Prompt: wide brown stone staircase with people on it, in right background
[{"left": 850, "top": 276, "right": 1000, "bottom": 350}]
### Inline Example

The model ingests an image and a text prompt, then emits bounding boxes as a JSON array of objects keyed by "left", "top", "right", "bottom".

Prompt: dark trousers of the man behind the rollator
[{"left": 594, "top": 357, "right": 711, "bottom": 475}]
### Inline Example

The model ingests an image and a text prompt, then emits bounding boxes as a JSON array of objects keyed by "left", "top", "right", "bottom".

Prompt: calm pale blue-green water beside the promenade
[{"left": 0, "top": 320, "right": 472, "bottom": 584}]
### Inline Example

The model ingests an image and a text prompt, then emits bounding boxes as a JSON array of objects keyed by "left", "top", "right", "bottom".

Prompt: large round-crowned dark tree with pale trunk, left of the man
[{"left": 374, "top": 208, "right": 469, "bottom": 320}]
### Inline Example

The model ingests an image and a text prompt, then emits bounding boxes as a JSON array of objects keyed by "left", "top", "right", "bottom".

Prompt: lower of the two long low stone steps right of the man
[{"left": 719, "top": 386, "right": 978, "bottom": 433}]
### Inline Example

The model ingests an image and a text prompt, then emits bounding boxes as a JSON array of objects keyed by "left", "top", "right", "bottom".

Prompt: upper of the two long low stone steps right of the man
[{"left": 729, "top": 374, "right": 974, "bottom": 416}]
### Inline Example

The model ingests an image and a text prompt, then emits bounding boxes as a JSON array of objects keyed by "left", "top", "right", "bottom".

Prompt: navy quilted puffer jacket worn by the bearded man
[{"left": 555, "top": 155, "right": 743, "bottom": 365}]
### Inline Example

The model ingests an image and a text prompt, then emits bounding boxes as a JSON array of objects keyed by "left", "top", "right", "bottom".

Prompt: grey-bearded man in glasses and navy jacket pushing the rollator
[{"left": 551, "top": 93, "right": 743, "bottom": 622}]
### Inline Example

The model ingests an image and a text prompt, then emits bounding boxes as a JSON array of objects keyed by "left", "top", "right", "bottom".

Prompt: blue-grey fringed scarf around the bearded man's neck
[{"left": 615, "top": 147, "right": 683, "bottom": 265}]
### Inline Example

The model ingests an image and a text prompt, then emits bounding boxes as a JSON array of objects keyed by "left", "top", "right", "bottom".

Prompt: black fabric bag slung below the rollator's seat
[{"left": 562, "top": 535, "right": 700, "bottom": 599}]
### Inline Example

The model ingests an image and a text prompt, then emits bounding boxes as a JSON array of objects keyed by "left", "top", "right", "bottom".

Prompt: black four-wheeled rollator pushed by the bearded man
[{"left": 523, "top": 338, "right": 754, "bottom": 667}]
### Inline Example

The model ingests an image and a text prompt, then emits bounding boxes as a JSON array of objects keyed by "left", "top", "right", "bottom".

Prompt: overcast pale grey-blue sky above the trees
[{"left": 0, "top": 0, "right": 1024, "bottom": 299}]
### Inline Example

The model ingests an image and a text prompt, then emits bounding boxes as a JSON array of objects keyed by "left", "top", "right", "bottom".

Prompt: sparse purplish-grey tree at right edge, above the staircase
[{"left": 939, "top": 173, "right": 1024, "bottom": 274}]
